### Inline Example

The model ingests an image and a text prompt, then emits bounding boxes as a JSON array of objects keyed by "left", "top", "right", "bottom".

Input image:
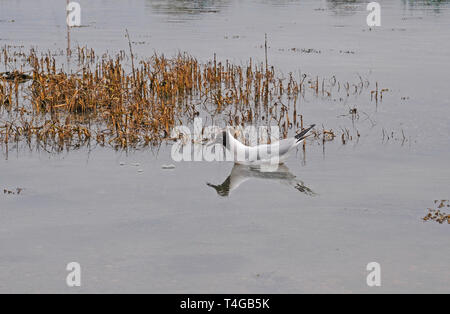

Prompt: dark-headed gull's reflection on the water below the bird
[{"left": 207, "top": 164, "right": 316, "bottom": 196}]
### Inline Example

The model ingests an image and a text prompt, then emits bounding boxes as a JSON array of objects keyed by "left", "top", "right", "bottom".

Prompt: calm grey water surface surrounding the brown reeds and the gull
[{"left": 0, "top": 0, "right": 450, "bottom": 293}]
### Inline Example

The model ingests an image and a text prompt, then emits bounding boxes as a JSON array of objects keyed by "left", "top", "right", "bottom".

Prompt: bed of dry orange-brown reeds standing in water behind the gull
[{"left": 0, "top": 47, "right": 372, "bottom": 150}]
